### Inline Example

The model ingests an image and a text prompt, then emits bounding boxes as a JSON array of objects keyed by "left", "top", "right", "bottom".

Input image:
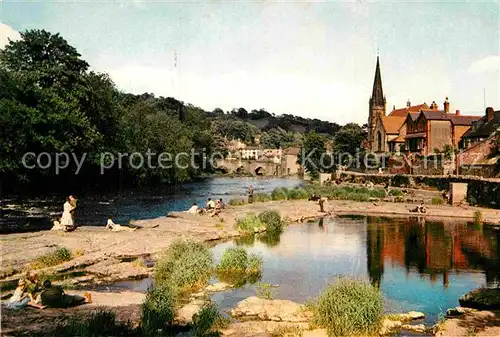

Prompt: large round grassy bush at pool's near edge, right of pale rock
[{"left": 312, "top": 278, "right": 383, "bottom": 337}]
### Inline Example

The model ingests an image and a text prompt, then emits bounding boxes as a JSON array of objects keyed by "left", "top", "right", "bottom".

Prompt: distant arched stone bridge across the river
[{"left": 217, "top": 158, "right": 281, "bottom": 176}]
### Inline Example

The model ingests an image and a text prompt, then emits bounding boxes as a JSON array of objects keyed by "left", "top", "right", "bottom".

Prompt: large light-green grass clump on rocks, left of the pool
[{"left": 155, "top": 240, "right": 213, "bottom": 291}]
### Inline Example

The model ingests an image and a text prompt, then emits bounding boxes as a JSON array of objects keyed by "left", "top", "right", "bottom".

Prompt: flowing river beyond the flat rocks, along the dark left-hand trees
[{"left": 0, "top": 177, "right": 301, "bottom": 234}]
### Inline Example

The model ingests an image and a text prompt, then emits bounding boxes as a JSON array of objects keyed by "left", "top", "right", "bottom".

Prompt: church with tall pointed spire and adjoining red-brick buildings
[{"left": 365, "top": 56, "right": 479, "bottom": 155}]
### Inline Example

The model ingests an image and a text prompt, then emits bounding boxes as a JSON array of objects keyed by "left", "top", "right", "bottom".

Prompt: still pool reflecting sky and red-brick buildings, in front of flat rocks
[{"left": 115, "top": 217, "right": 500, "bottom": 324}]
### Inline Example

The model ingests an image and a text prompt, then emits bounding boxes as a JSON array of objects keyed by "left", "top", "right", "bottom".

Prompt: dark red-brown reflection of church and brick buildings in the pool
[{"left": 367, "top": 218, "right": 500, "bottom": 287}]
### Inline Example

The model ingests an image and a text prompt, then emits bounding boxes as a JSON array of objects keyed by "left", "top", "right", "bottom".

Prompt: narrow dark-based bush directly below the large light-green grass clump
[{"left": 142, "top": 283, "right": 175, "bottom": 336}]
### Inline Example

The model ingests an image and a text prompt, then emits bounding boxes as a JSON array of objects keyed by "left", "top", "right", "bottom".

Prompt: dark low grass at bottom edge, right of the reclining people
[{"left": 51, "top": 309, "right": 133, "bottom": 337}]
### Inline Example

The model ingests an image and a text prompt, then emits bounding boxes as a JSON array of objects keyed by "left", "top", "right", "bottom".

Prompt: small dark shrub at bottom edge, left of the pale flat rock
[{"left": 192, "top": 303, "right": 229, "bottom": 337}]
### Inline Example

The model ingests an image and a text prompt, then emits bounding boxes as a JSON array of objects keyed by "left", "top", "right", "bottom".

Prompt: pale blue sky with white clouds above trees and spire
[{"left": 0, "top": 0, "right": 500, "bottom": 124}]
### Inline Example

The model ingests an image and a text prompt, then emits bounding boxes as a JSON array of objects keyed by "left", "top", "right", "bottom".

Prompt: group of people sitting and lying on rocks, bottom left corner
[{"left": 5, "top": 270, "right": 92, "bottom": 309}]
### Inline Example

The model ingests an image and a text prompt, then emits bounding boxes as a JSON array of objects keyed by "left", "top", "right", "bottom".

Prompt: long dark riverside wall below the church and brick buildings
[{"left": 340, "top": 172, "right": 500, "bottom": 209}]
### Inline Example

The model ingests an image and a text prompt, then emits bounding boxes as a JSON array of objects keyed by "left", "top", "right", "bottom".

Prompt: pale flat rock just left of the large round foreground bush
[{"left": 230, "top": 296, "right": 312, "bottom": 322}]
